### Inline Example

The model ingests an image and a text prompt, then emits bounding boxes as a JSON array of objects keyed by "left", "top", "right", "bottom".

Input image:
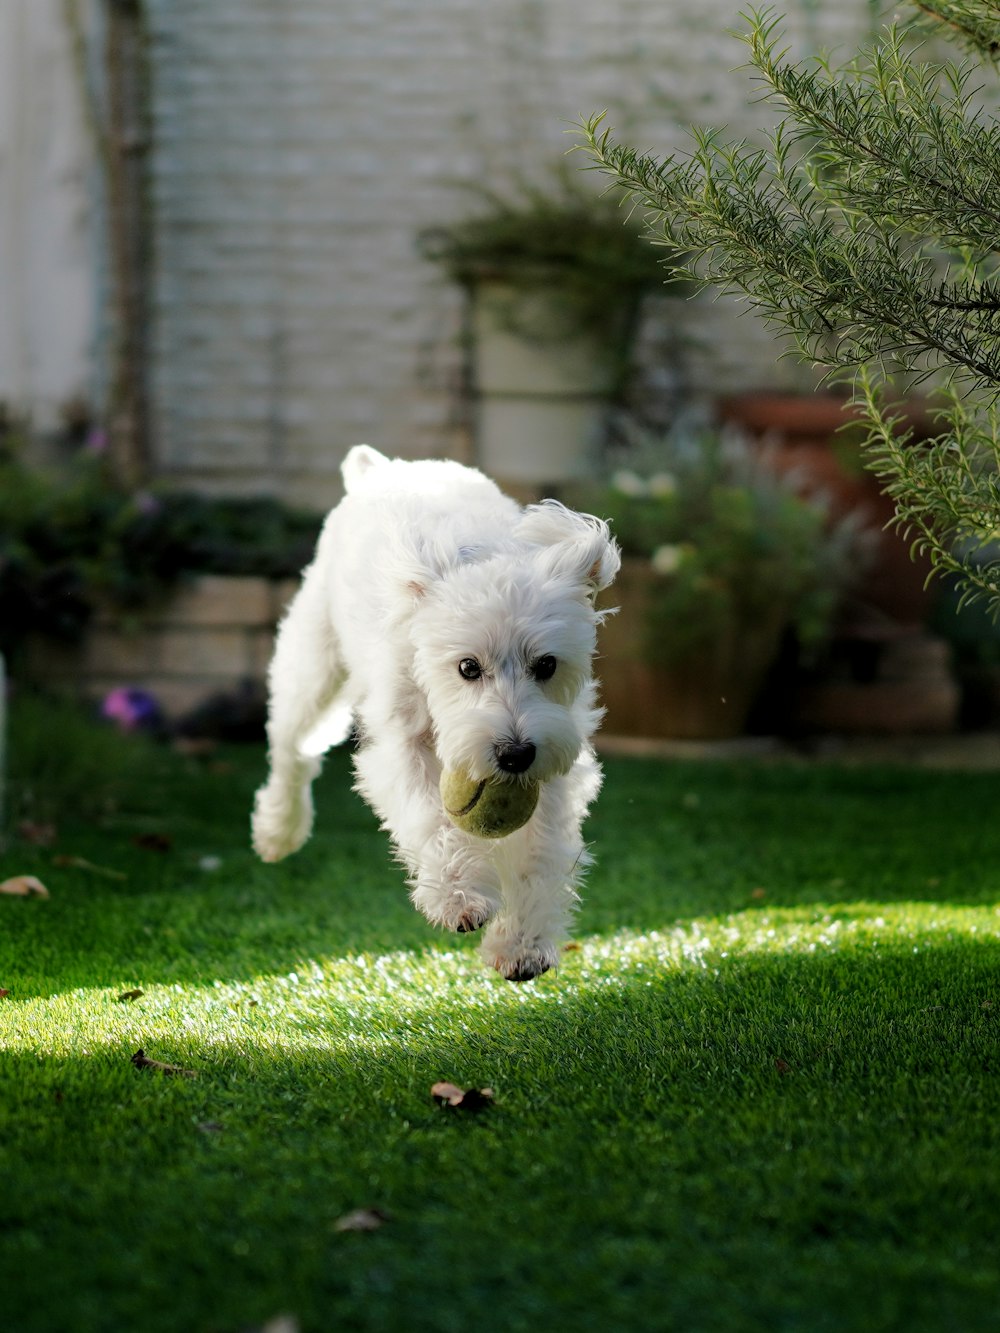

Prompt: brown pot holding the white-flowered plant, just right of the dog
[{"left": 597, "top": 560, "right": 785, "bottom": 740}]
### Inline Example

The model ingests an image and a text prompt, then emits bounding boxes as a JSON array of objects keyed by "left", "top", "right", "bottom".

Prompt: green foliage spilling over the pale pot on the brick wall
[{"left": 420, "top": 177, "right": 667, "bottom": 324}]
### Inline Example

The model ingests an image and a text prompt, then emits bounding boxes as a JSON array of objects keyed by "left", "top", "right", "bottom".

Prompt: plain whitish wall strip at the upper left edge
[{"left": 0, "top": 0, "right": 99, "bottom": 431}]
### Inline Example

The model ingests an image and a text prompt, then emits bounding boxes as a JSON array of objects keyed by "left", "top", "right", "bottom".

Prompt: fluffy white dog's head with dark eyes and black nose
[{"left": 412, "top": 501, "right": 620, "bottom": 781}]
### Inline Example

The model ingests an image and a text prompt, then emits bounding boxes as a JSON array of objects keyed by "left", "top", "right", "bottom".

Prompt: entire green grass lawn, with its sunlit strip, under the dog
[{"left": 0, "top": 713, "right": 1000, "bottom": 1333}]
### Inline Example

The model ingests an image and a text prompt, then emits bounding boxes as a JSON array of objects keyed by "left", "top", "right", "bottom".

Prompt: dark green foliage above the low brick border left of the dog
[{"left": 0, "top": 444, "right": 320, "bottom": 653}]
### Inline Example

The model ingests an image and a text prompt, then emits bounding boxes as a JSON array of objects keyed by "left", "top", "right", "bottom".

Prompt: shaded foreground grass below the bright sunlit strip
[{"left": 3, "top": 938, "right": 1000, "bottom": 1330}]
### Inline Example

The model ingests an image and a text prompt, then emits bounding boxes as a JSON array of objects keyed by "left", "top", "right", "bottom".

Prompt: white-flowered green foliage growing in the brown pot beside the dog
[{"left": 573, "top": 424, "right": 863, "bottom": 663}]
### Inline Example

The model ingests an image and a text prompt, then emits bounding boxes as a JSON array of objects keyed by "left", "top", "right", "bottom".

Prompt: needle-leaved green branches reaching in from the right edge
[{"left": 584, "top": 0, "right": 1000, "bottom": 607}]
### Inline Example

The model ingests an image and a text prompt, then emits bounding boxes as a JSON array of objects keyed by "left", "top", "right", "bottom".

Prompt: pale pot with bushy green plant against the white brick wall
[{"left": 420, "top": 181, "right": 677, "bottom": 484}]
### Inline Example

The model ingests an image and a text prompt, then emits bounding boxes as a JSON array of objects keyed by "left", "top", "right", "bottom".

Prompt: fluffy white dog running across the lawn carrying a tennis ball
[{"left": 253, "top": 445, "right": 620, "bottom": 981}]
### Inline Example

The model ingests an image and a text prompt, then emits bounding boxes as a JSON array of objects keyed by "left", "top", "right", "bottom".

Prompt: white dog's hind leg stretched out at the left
[{"left": 252, "top": 560, "right": 351, "bottom": 861}]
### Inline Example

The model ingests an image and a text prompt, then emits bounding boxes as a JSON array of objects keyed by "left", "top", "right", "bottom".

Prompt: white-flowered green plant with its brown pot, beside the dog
[{"left": 573, "top": 425, "right": 859, "bottom": 738}]
